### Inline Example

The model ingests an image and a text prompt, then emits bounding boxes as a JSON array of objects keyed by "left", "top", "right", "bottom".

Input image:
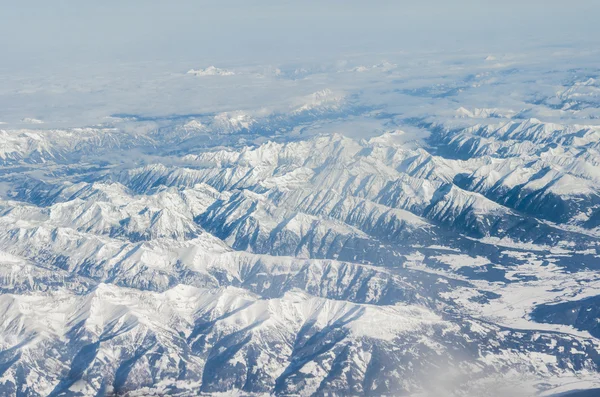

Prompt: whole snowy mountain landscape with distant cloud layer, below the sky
[{"left": 0, "top": 49, "right": 600, "bottom": 396}]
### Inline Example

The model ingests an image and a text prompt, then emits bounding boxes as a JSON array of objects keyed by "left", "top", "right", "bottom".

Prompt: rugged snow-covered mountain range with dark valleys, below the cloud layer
[{"left": 0, "top": 113, "right": 600, "bottom": 396}]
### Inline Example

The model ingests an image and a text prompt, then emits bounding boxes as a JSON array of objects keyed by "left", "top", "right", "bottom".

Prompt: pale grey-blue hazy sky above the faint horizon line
[{"left": 0, "top": 0, "right": 600, "bottom": 68}]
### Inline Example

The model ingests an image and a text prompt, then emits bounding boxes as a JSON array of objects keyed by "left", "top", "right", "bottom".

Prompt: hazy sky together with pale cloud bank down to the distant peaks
[{"left": 0, "top": 0, "right": 600, "bottom": 128}]
